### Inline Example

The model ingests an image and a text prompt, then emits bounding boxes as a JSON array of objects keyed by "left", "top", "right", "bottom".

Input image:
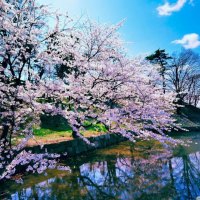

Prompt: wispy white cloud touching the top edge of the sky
[{"left": 157, "top": 0, "right": 188, "bottom": 16}]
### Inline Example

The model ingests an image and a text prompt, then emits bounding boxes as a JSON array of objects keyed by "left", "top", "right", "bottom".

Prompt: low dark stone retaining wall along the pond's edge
[{"left": 27, "top": 134, "right": 126, "bottom": 156}]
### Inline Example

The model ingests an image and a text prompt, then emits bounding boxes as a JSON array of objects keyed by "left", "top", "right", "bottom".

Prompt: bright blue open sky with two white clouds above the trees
[{"left": 39, "top": 0, "right": 200, "bottom": 55}]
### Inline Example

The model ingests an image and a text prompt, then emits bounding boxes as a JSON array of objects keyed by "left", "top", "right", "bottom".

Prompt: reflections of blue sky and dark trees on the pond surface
[{"left": 2, "top": 143, "right": 200, "bottom": 200}]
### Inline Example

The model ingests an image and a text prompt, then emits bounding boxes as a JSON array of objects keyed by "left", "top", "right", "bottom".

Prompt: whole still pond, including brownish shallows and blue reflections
[{"left": 0, "top": 133, "right": 200, "bottom": 200}]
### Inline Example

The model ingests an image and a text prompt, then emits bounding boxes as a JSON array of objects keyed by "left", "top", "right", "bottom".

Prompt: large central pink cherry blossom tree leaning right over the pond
[{"left": 65, "top": 21, "right": 181, "bottom": 145}]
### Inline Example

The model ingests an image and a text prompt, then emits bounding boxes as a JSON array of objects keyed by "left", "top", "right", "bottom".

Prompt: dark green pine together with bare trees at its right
[{"left": 146, "top": 49, "right": 200, "bottom": 107}]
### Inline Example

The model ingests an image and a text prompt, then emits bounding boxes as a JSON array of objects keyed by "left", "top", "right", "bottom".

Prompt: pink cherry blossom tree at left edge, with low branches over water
[{"left": 0, "top": 0, "right": 73, "bottom": 180}]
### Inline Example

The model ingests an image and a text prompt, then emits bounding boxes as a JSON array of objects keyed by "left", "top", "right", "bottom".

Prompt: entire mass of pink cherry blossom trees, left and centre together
[{"left": 0, "top": 0, "right": 181, "bottom": 179}]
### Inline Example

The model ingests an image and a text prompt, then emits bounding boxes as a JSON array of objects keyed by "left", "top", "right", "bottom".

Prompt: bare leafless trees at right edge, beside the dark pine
[{"left": 168, "top": 50, "right": 200, "bottom": 106}]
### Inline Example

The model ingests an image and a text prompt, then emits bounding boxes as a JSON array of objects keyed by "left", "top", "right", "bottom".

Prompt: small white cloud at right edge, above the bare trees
[{"left": 172, "top": 33, "right": 200, "bottom": 49}]
